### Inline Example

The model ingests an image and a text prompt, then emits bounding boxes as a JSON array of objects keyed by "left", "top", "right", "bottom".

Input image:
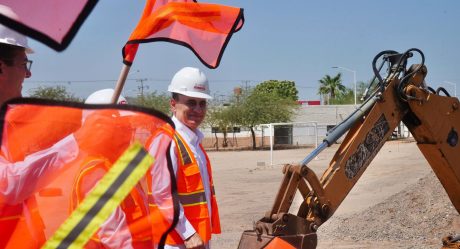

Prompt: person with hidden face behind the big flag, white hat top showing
[{"left": 70, "top": 89, "right": 154, "bottom": 249}]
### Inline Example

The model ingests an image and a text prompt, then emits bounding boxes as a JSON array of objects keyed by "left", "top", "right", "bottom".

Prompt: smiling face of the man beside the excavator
[{"left": 171, "top": 94, "right": 207, "bottom": 130}]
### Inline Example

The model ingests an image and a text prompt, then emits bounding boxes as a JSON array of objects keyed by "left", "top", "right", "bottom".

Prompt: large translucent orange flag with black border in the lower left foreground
[{"left": 0, "top": 99, "right": 179, "bottom": 248}]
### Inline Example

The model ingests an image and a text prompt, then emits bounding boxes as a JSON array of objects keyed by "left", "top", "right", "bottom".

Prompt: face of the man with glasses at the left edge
[{"left": 0, "top": 51, "right": 32, "bottom": 102}]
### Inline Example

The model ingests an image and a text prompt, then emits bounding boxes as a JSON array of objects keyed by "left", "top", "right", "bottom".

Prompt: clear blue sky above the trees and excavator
[{"left": 23, "top": 0, "right": 460, "bottom": 100}]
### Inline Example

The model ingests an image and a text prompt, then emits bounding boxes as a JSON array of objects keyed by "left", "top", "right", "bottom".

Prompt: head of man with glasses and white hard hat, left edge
[{"left": 0, "top": 22, "right": 33, "bottom": 105}]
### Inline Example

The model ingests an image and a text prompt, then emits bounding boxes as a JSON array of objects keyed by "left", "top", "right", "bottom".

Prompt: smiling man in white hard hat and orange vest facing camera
[{"left": 149, "top": 67, "right": 221, "bottom": 249}]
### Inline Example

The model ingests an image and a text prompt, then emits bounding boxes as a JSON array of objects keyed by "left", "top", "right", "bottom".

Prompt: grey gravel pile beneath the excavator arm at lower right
[{"left": 318, "top": 173, "right": 460, "bottom": 248}]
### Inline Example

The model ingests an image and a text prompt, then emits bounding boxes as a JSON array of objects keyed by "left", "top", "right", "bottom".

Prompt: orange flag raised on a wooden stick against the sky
[{"left": 123, "top": 0, "right": 244, "bottom": 68}]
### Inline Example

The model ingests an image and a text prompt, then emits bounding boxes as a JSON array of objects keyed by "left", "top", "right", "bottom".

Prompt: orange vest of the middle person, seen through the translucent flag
[{"left": 70, "top": 157, "right": 153, "bottom": 249}]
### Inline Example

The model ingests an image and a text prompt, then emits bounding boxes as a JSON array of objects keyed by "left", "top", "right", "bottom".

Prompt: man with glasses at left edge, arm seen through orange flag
[{"left": 0, "top": 25, "right": 78, "bottom": 248}]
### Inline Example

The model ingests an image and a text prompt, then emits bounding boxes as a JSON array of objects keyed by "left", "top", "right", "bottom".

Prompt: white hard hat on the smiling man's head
[{"left": 168, "top": 67, "right": 212, "bottom": 99}]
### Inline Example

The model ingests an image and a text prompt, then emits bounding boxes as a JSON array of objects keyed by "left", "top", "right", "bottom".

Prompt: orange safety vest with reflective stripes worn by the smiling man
[{"left": 147, "top": 133, "right": 221, "bottom": 245}]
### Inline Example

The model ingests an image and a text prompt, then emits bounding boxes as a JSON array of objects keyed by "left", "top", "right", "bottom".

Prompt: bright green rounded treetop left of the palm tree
[{"left": 254, "top": 80, "right": 299, "bottom": 101}]
